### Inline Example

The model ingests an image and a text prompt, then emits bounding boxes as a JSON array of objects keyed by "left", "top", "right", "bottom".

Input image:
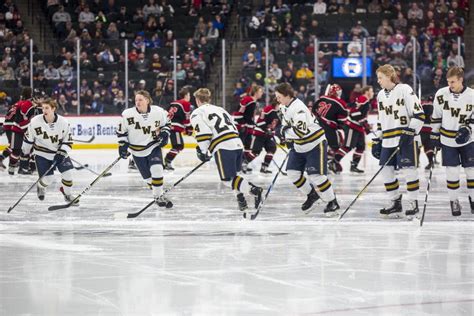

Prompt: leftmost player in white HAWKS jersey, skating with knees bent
[{"left": 21, "top": 99, "right": 79, "bottom": 205}]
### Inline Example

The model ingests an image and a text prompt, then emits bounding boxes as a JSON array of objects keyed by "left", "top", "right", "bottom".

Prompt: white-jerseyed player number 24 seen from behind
[{"left": 191, "top": 88, "right": 263, "bottom": 216}]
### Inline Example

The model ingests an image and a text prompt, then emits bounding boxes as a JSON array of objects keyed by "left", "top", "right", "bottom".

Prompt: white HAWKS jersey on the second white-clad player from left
[{"left": 117, "top": 105, "right": 170, "bottom": 157}]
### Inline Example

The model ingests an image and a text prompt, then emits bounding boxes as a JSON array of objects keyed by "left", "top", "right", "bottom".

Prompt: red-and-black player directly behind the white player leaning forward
[{"left": 312, "top": 84, "right": 348, "bottom": 173}]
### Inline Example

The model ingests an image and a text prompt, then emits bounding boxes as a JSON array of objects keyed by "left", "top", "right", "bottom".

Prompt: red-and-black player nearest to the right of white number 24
[{"left": 232, "top": 85, "right": 263, "bottom": 173}]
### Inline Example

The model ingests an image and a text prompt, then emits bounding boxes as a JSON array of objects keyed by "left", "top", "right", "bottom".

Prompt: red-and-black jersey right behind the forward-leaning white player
[{"left": 313, "top": 95, "right": 348, "bottom": 129}]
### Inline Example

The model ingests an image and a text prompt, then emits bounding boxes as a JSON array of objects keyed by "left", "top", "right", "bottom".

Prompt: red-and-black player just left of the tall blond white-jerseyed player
[{"left": 330, "top": 86, "right": 374, "bottom": 173}]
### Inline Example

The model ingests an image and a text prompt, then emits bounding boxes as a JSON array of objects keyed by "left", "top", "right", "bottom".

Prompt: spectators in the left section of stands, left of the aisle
[{"left": 0, "top": 0, "right": 231, "bottom": 114}]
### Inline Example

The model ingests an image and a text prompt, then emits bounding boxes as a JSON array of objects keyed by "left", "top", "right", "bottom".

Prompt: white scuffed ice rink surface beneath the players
[{"left": 0, "top": 150, "right": 474, "bottom": 316}]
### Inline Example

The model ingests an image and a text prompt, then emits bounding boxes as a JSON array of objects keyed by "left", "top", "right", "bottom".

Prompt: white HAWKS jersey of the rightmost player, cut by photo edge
[{"left": 431, "top": 87, "right": 474, "bottom": 147}]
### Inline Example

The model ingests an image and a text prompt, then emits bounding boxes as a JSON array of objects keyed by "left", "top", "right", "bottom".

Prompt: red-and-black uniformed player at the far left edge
[{"left": 0, "top": 87, "right": 35, "bottom": 175}]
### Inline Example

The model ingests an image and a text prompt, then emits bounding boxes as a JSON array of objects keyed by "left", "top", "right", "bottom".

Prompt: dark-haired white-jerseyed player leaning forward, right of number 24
[{"left": 275, "top": 83, "right": 339, "bottom": 216}]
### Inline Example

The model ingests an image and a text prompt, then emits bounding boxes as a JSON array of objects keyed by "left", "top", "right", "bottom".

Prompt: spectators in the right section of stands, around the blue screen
[{"left": 239, "top": 0, "right": 470, "bottom": 106}]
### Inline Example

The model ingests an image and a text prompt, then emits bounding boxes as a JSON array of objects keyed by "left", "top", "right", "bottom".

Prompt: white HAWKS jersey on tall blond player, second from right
[{"left": 376, "top": 83, "right": 425, "bottom": 148}]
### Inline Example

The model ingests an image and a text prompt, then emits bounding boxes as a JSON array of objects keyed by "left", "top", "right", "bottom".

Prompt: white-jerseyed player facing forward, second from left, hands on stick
[{"left": 117, "top": 90, "right": 173, "bottom": 208}]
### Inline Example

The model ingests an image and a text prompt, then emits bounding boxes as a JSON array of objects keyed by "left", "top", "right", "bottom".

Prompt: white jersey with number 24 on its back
[{"left": 191, "top": 104, "right": 244, "bottom": 154}]
